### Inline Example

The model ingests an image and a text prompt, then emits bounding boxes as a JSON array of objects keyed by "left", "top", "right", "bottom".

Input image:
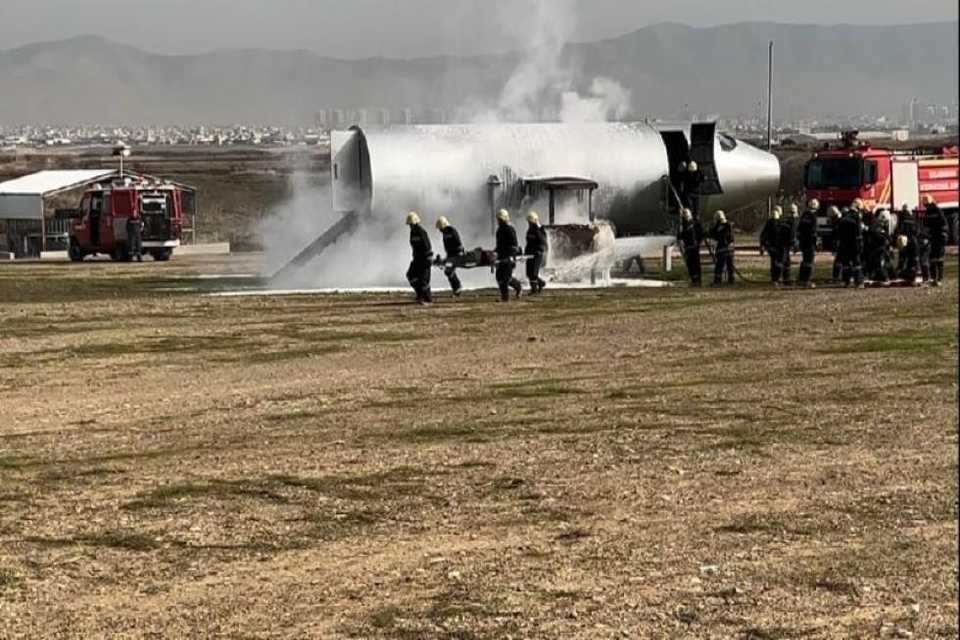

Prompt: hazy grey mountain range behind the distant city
[{"left": 0, "top": 22, "right": 960, "bottom": 125}]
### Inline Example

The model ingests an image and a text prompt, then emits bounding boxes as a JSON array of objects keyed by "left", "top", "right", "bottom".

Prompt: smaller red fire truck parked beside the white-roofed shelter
[{"left": 65, "top": 176, "right": 193, "bottom": 262}]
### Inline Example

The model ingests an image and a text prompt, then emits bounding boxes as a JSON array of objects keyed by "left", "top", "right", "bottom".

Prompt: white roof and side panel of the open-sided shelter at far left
[{"left": 0, "top": 169, "right": 117, "bottom": 220}]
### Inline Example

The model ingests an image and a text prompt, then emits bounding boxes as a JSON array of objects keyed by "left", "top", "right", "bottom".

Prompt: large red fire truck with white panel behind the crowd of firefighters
[{"left": 804, "top": 132, "right": 960, "bottom": 248}]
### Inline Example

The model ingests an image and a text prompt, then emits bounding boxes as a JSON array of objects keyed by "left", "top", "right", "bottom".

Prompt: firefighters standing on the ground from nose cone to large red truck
[{"left": 677, "top": 196, "right": 948, "bottom": 288}]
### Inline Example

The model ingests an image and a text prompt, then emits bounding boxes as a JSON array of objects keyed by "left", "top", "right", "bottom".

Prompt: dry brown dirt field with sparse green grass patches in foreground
[{"left": 0, "top": 255, "right": 958, "bottom": 640}]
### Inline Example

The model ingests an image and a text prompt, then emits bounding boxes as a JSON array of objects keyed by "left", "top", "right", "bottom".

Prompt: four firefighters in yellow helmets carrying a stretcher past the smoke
[{"left": 407, "top": 209, "right": 547, "bottom": 305}]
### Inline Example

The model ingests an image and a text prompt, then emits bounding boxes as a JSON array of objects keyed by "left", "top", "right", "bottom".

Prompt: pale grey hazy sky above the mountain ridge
[{"left": 0, "top": 0, "right": 958, "bottom": 58}]
